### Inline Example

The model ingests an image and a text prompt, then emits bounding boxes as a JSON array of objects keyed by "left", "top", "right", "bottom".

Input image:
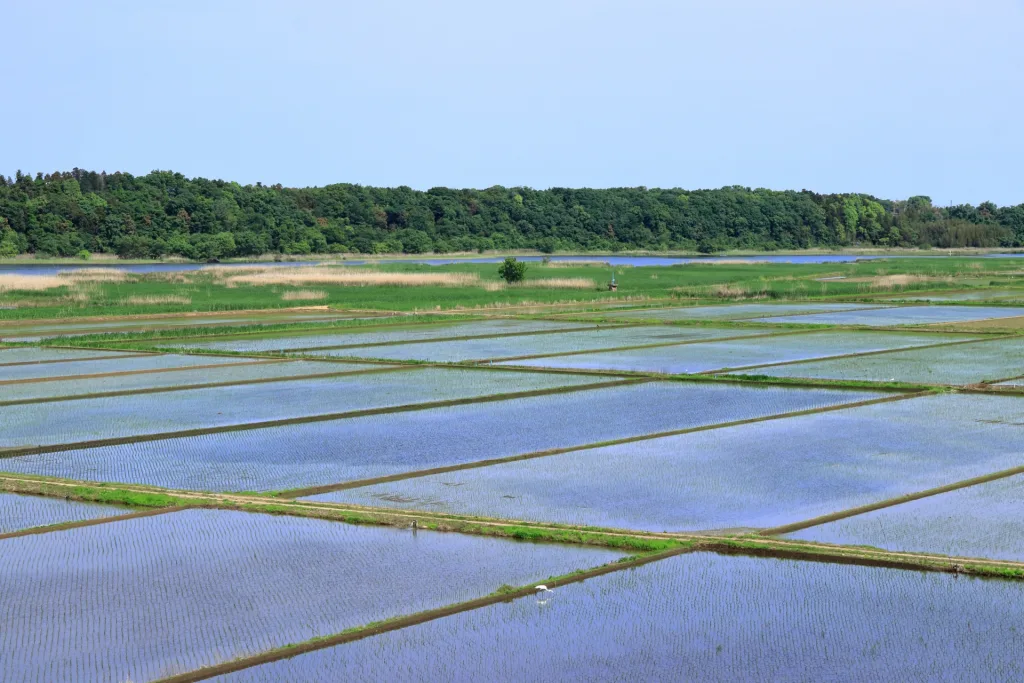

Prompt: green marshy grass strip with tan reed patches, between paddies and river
[{"left": 0, "top": 257, "right": 1024, "bottom": 321}]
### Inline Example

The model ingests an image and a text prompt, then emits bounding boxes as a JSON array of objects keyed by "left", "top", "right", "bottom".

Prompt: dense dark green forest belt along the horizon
[{"left": 0, "top": 168, "right": 1024, "bottom": 260}]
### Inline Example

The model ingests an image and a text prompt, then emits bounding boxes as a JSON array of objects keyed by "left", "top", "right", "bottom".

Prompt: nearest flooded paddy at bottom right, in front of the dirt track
[{"left": 207, "top": 553, "right": 1024, "bottom": 683}]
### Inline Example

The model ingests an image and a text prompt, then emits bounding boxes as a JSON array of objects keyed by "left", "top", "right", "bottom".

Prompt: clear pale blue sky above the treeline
[{"left": 8, "top": 0, "right": 1024, "bottom": 205}]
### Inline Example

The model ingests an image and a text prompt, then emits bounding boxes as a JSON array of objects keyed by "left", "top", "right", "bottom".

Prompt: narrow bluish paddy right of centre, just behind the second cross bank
[{"left": 499, "top": 330, "right": 971, "bottom": 375}]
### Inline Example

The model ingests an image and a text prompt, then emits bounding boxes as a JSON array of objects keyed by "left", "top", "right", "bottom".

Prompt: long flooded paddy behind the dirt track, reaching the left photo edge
[{"left": 0, "top": 382, "right": 882, "bottom": 490}]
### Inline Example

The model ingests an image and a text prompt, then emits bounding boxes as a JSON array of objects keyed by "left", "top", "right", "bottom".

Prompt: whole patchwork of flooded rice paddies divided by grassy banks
[{"left": 6, "top": 301, "right": 1024, "bottom": 682}]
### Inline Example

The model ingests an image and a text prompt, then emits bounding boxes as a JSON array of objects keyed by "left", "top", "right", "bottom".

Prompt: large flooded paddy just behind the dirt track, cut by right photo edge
[{"left": 310, "top": 394, "right": 1024, "bottom": 531}]
